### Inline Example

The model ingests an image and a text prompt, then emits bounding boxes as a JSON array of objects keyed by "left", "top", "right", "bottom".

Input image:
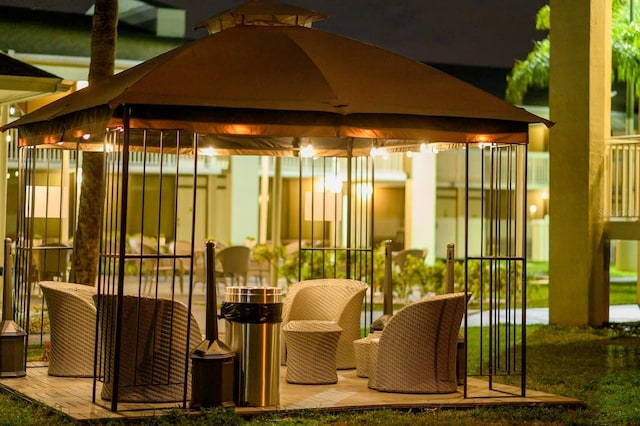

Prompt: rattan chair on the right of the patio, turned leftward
[{"left": 369, "top": 293, "right": 467, "bottom": 393}]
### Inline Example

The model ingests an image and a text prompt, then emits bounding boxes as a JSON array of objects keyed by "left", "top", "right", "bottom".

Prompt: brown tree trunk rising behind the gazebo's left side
[{"left": 71, "top": 0, "right": 118, "bottom": 285}]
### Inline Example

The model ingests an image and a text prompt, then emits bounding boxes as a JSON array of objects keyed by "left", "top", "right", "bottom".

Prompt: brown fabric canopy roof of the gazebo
[{"left": 1, "top": 2, "right": 551, "bottom": 155}]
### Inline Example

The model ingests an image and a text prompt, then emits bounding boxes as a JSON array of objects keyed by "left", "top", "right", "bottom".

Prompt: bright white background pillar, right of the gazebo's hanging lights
[{"left": 405, "top": 153, "right": 436, "bottom": 265}]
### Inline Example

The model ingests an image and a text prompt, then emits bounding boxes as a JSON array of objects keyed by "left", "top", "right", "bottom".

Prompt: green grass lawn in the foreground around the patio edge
[{"left": 0, "top": 325, "right": 640, "bottom": 426}]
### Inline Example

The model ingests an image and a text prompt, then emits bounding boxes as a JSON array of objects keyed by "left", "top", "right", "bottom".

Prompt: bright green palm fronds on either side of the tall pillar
[{"left": 506, "top": 0, "right": 640, "bottom": 117}]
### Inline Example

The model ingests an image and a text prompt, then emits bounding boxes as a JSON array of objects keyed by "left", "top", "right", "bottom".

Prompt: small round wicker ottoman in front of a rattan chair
[{"left": 282, "top": 320, "right": 342, "bottom": 385}]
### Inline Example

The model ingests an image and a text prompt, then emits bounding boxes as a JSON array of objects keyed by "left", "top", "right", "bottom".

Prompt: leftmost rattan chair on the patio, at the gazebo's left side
[{"left": 40, "top": 281, "right": 96, "bottom": 377}]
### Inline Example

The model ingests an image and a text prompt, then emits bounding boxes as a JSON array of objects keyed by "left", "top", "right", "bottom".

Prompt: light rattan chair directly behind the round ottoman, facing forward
[{"left": 281, "top": 278, "right": 367, "bottom": 369}]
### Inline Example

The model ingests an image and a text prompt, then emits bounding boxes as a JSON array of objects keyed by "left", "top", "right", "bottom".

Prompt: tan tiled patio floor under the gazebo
[{"left": 0, "top": 363, "right": 584, "bottom": 421}]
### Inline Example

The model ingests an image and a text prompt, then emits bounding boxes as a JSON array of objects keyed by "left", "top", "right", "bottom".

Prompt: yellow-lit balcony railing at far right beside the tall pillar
[{"left": 601, "top": 135, "right": 640, "bottom": 220}]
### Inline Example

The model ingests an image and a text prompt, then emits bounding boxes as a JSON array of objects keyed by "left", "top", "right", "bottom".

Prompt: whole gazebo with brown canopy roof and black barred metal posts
[{"left": 5, "top": 0, "right": 551, "bottom": 410}]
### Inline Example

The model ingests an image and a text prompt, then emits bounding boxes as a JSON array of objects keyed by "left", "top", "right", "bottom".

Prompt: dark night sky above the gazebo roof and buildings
[{"left": 0, "top": 0, "right": 548, "bottom": 68}]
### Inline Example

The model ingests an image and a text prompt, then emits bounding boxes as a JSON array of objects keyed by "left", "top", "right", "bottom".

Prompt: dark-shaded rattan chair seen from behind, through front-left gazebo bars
[{"left": 96, "top": 295, "right": 202, "bottom": 402}]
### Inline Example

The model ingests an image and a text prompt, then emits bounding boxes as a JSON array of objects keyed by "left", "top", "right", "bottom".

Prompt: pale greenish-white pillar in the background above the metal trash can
[{"left": 229, "top": 155, "right": 260, "bottom": 244}]
